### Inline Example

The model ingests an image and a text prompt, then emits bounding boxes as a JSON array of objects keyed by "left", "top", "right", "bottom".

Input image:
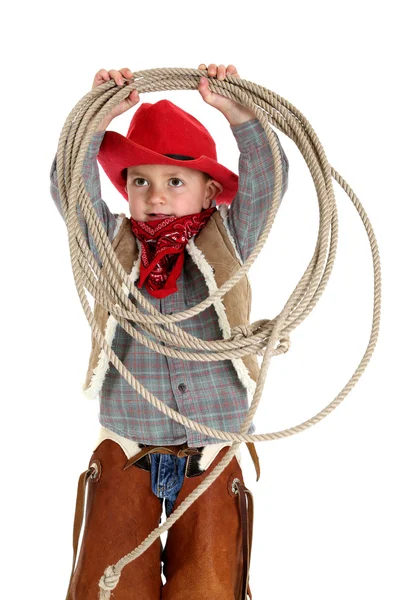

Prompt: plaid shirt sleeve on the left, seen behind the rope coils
[{"left": 50, "top": 130, "right": 116, "bottom": 266}]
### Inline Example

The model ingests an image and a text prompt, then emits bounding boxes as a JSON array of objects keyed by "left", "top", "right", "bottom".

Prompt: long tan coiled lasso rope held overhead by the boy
[{"left": 57, "top": 69, "right": 381, "bottom": 600}]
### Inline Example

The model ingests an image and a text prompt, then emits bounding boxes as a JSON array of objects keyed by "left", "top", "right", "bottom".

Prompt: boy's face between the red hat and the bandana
[{"left": 125, "top": 165, "right": 223, "bottom": 221}]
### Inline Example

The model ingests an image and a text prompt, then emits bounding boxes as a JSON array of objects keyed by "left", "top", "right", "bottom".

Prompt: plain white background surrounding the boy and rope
[{"left": 1, "top": 0, "right": 400, "bottom": 600}]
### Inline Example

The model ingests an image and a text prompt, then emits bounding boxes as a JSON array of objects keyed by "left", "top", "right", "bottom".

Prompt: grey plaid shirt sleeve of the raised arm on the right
[{"left": 227, "top": 118, "right": 289, "bottom": 262}]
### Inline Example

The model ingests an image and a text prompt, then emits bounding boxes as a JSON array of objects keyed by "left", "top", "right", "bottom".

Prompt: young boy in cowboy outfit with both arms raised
[{"left": 50, "top": 64, "right": 288, "bottom": 600}]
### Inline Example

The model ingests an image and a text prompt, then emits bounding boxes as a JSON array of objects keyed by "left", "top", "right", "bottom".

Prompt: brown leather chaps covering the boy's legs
[{"left": 67, "top": 439, "right": 253, "bottom": 600}]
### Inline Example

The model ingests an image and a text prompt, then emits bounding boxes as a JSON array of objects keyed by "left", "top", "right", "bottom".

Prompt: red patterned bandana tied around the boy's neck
[{"left": 130, "top": 206, "right": 217, "bottom": 298}]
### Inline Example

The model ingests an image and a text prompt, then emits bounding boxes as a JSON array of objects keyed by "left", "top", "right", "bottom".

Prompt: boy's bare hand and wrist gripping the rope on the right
[{"left": 198, "top": 63, "right": 256, "bottom": 125}]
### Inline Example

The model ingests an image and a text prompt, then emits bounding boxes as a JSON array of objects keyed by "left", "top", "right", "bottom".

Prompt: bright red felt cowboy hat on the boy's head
[{"left": 97, "top": 100, "right": 239, "bottom": 205}]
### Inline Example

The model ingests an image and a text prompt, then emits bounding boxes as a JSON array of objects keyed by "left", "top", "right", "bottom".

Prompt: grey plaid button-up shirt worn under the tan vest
[{"left": 50, "top": 119, "right": 289, "bottom": 447}]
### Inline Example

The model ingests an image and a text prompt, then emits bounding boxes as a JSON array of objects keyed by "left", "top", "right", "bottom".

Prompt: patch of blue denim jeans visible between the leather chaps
[{"left": 150, "top": 453, "right": 188, "bottom": 517}]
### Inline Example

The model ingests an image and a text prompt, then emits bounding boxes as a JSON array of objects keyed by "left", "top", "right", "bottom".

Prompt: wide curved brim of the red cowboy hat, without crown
[{"left": 97, "top": 131, "right": 239, "bottom": 205}]
